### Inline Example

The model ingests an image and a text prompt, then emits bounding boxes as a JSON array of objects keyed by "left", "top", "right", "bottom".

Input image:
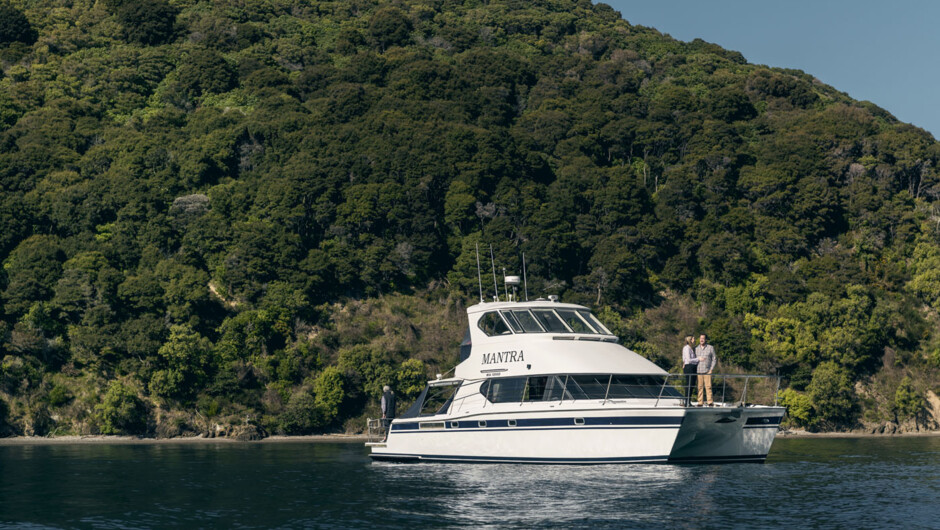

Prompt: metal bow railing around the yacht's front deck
[{"left": 656, "top": 374, "right": 780, "bottom": 407}]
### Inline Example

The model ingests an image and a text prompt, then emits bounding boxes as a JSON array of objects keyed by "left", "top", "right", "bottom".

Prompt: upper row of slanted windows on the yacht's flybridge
[{"left": 477, "top": 307, "right": 613, "bottom": 337}]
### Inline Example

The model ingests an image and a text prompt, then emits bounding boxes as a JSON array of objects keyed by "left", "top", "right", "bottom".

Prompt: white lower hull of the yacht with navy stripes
[{"left": 370, "top": 407, "right": 783, "bottom": 464}]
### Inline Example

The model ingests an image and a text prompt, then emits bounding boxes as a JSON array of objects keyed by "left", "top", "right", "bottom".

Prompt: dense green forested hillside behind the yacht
[{"left": 0, "top": 0, "right": 940, "bottom": 437}]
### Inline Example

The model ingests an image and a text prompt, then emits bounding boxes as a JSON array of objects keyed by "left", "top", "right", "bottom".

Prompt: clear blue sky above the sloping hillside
[{"left": 605, "top": 0, "right": 940, "bottom": 137}]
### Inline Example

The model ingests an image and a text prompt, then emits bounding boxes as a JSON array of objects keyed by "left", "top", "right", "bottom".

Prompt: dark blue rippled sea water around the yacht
[{"left": 0, "top": 437, "right": 940, "bottom": 529}]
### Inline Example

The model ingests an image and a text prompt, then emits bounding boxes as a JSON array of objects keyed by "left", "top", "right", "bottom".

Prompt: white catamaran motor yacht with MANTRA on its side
[{"left": 367, "top": 297, "right": 784, "bottom": 464}]
